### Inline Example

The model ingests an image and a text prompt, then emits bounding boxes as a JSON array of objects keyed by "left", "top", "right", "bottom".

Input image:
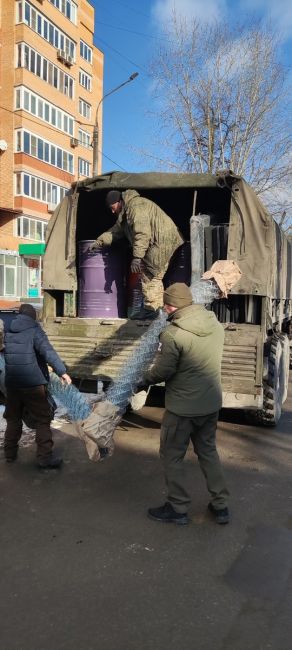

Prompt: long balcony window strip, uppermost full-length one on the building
[{"left": 17, "top": 0, "right": 76, "bottom": 60}]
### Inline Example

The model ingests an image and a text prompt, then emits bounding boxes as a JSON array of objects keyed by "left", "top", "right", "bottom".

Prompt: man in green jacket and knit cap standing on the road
[{"left": 145, "top": 283, "right": 229, "bottom": 524}]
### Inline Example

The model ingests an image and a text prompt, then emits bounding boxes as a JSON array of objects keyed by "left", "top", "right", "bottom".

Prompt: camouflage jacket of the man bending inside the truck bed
[{"left": 98, "top": 190, "right": 184, "bottom": 276}]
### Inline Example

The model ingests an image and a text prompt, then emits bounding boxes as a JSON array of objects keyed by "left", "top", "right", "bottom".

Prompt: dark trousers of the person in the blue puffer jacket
[{"left": 4, "top": 386, "right": 54, "bottom": 461}]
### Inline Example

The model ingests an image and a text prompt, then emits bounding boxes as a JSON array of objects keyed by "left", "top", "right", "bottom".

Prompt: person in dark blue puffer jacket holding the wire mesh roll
[{"left": 4, "top": 304, "right": 71, "bottom": 469}]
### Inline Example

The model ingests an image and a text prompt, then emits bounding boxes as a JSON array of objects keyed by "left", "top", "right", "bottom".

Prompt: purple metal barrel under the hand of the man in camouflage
[{"left": 78, "top": 239, "right": 127, "bottom": 318}]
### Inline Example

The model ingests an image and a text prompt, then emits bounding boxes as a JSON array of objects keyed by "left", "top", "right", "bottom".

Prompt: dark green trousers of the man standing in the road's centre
[{"left": 160, "top": 411, "right": 229, "bottom": 512}]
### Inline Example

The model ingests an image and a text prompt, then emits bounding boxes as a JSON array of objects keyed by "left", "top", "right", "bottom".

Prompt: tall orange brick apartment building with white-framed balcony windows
[{"left": 0, "top": 0, "right": 103, "bottom": 302}]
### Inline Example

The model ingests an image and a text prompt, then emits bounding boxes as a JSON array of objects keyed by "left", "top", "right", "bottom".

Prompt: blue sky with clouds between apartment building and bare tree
[{"left": 91, "top": 0, "right": 292, "bottom": 172}]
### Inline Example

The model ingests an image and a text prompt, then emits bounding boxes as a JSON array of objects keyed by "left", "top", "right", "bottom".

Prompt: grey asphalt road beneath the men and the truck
[{"left": 0, "top": 374, "right": 292, "bottom": 650}]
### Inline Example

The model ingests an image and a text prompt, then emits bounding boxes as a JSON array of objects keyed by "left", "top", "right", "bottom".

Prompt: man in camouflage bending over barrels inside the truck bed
[{"left": 90, "top": 190, "right": 184, "bottom": 318}]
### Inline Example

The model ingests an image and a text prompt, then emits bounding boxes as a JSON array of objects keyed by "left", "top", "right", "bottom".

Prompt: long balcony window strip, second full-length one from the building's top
[{"left": 17, "top": 43, "right": 74, "bottom": 99}]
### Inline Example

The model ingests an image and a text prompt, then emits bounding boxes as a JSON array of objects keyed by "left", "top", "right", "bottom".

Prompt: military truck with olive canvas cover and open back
[{"left": 43, "top": 172, "right": 292, "bottom": 426}]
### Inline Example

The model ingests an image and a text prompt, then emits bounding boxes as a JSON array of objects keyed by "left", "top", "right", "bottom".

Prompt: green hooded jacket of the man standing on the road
[{"left": 145, "top": 305, "right": 224, "bottom": 417}]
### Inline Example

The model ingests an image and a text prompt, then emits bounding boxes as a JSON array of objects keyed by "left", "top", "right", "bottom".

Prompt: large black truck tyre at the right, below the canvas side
[{"left": 247, "top": 334, "right": 290, "bottom": 427}]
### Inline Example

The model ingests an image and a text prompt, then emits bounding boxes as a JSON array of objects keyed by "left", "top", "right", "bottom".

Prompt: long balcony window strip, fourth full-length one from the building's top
[{"left": 16, "top": 129, "right": 74, "bottom": 173}]
